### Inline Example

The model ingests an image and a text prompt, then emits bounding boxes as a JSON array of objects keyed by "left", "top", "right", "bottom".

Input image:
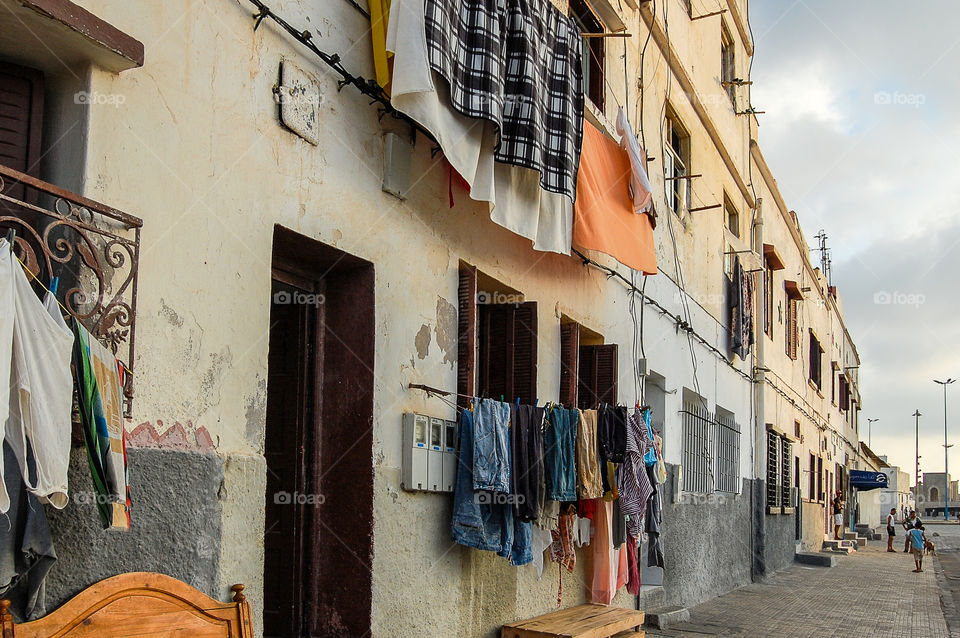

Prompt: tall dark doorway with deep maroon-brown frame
[{"left": 263, "top": 227, "right": 375, "bottom": 638}]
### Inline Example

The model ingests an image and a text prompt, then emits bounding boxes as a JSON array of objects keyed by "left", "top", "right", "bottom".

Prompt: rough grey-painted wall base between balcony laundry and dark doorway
[{"left": 46, "top": 448, "right": 223, "bottom": 611}]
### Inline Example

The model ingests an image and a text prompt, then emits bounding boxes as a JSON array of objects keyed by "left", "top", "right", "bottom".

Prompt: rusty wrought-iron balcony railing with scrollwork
[{"left": 0, "top": 164, "right": 143, "bottom": 418}]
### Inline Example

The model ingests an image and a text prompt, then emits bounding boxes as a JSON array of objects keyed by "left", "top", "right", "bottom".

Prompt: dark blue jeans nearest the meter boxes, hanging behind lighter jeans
[{"left": 450, "top": 410, "right": 533, "bottom": 565}]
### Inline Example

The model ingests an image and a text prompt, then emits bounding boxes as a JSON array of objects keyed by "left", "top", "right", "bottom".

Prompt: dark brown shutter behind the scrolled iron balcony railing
[{"left": 0, "top": 64, "right": 43, "bottom": 211}]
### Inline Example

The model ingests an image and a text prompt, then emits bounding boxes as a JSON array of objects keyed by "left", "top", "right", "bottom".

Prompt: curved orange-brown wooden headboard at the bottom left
[{"left": 0, "top": 572, "right": 253, "bottom": 638}]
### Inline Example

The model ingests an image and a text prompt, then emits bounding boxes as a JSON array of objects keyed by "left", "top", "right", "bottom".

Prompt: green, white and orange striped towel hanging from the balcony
[{"left": 73, "top": 319, "right": 130, "bottom": 530}]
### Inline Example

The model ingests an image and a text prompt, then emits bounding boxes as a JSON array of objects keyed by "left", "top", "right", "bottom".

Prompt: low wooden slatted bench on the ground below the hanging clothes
[{"left": 500, "top": 604, "right": 644, "bottom": 638}]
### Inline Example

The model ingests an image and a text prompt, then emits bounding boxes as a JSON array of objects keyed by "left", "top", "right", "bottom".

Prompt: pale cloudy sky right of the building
[{"left": 750, "top": 0, "right": 960, "bottom": 492}]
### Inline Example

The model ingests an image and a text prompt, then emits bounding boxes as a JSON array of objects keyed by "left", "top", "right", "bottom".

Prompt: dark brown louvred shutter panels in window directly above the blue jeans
[{"left": 478, "top": 302, "right": 537, "bottom": 404}]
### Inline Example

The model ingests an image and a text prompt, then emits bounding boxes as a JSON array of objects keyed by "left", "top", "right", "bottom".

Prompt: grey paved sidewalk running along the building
[{"left": 647, "top": 539, "right": 950, "bottom": 638}]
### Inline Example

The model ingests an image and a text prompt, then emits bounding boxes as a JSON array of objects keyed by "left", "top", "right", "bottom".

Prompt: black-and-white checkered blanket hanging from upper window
[{"left": 425, "top": 0, "right": 584, "bottom": 200}]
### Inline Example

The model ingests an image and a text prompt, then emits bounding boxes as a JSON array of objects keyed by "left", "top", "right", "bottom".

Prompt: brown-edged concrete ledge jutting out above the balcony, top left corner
[{"left": 0, "top": 0, "right": 144, "bottom": 73}]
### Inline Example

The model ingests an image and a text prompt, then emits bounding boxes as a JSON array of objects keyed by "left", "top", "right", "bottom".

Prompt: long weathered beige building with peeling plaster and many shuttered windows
[{"left": 0, "top": 0, "right": 872, "bottom": 636}]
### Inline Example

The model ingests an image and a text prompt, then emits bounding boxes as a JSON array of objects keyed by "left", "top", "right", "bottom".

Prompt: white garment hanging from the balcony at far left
[{"left": 0, "top": 241, "right": 73, "bottom": 512}]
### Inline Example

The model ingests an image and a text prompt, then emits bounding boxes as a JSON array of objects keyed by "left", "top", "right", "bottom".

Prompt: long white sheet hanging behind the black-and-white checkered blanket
[{"left": 387, "top": 0, "right": 580, "bottom": 255}]
